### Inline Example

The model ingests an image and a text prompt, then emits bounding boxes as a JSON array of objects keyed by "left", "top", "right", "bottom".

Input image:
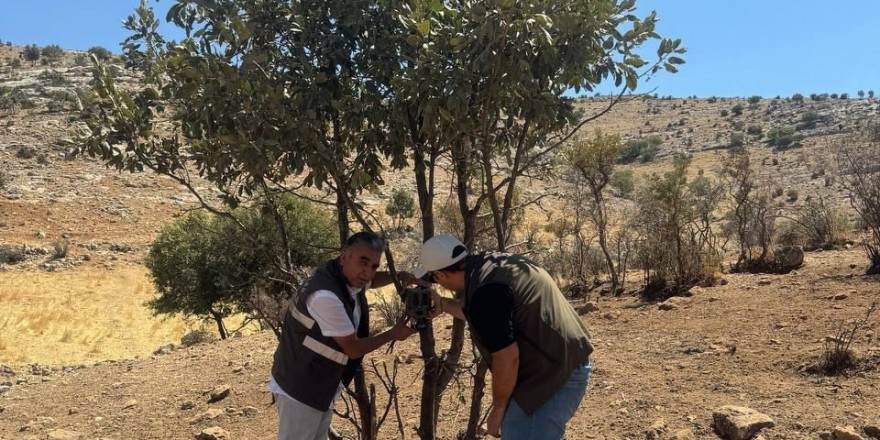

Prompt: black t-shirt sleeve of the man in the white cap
[{"left": 467, "top": 284, "right": 516, "bottom": 353}]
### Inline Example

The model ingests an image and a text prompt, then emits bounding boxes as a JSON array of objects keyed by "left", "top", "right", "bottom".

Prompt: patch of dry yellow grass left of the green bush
[{"left": 0, "top": 266, "right": 187, "bottom": 365}]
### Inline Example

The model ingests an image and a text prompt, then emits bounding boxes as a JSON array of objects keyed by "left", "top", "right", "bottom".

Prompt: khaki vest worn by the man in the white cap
[{"left": 464, "top": 253, "right": 593, "bottom": 414}]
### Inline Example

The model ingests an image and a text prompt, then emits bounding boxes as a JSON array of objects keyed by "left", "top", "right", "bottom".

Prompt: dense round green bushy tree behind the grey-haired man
[{"left": 145, "top": 198, "right": 336, "bottom": 339}]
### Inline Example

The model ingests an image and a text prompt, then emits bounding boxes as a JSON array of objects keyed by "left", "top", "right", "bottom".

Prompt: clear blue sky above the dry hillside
[{"left": 0, "top": 0, "right": 880, "bottom": 97}]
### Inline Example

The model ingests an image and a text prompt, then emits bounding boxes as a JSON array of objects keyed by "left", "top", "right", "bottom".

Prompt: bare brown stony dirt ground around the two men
[{"left": 0, "top": 251, "right": 880, "bottom": 439}]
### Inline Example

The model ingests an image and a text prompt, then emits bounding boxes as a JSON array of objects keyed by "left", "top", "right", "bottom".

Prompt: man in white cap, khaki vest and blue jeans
[{"left": 414, "top": 235, "right": 593, "bottom": 440}]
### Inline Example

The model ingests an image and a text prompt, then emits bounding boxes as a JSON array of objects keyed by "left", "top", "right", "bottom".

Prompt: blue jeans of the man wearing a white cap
[{"left": 501, "top": 362, "right": 592, "bottom": 440}]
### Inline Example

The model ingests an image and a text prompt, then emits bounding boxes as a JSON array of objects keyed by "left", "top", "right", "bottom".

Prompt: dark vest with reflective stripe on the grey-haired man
[{"left": 272, "top": 260, "right": 370, "bottom": 412}]
